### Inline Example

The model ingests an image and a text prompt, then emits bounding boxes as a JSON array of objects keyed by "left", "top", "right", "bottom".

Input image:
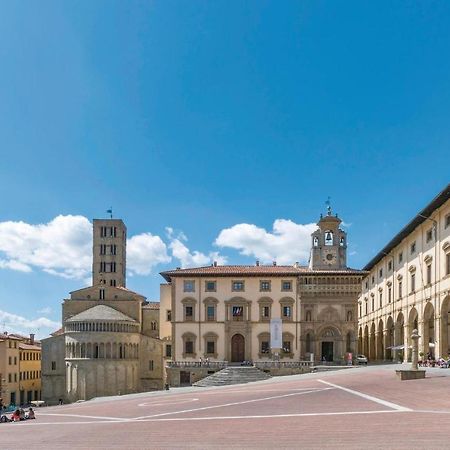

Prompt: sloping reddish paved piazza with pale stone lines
[{"left": 0, "top": 365, "right": 450, "bottom": 449}]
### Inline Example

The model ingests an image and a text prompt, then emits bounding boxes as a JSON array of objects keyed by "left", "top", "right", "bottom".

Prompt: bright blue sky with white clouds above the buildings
[{"left": 0, "top": 0, "right": 450, "bottom": 335}]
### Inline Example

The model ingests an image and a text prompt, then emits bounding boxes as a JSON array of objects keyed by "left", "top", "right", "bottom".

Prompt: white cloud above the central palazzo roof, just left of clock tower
[{"left": 215, "top": 219, "right": 317, "bottom": 264}]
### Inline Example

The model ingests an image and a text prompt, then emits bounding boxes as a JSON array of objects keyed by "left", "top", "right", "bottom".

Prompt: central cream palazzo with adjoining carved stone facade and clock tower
[{"left": 160, "top": 209, "right": 363, "bottom": 382}]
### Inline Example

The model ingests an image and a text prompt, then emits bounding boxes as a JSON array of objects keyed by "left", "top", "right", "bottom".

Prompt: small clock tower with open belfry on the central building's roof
[{"left": 309, "top": 206, "right": 347, "bottom": 270}]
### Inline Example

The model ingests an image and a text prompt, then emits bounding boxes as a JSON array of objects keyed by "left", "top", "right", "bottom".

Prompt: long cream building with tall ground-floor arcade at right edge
[{"left": 358, "top": 185, "right": 450, "bottom": 361}]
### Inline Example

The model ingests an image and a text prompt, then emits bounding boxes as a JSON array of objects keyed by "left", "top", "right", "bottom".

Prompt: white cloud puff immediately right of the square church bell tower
[{"left": 127, "top": 233, "right": 171, "bottom": 275}]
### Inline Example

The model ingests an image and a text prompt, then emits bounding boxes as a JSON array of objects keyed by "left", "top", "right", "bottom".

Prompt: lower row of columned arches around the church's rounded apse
[{"left": 66, "top": 342, "right": 139, "bottom": 359}]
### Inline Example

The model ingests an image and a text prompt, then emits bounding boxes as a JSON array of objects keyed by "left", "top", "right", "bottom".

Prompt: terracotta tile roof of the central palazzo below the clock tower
[{"left": 161, "top": 265, "right": 361, "bottom": 281}]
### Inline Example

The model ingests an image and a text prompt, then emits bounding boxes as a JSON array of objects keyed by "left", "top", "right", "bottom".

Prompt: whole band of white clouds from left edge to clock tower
[{"left": 0, "top": 215, "right": 316, "bottom": 278}]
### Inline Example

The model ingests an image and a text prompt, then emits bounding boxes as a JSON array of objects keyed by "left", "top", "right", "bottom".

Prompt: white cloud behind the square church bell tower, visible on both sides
[{"left": 0, "top": 215, "right": 171, "bottom": 284}]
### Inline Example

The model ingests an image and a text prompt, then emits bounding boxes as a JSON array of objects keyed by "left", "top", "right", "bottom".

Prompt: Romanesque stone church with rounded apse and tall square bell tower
[{"left": 42, "top": 219, "right": 164, "bottom": 403}]
